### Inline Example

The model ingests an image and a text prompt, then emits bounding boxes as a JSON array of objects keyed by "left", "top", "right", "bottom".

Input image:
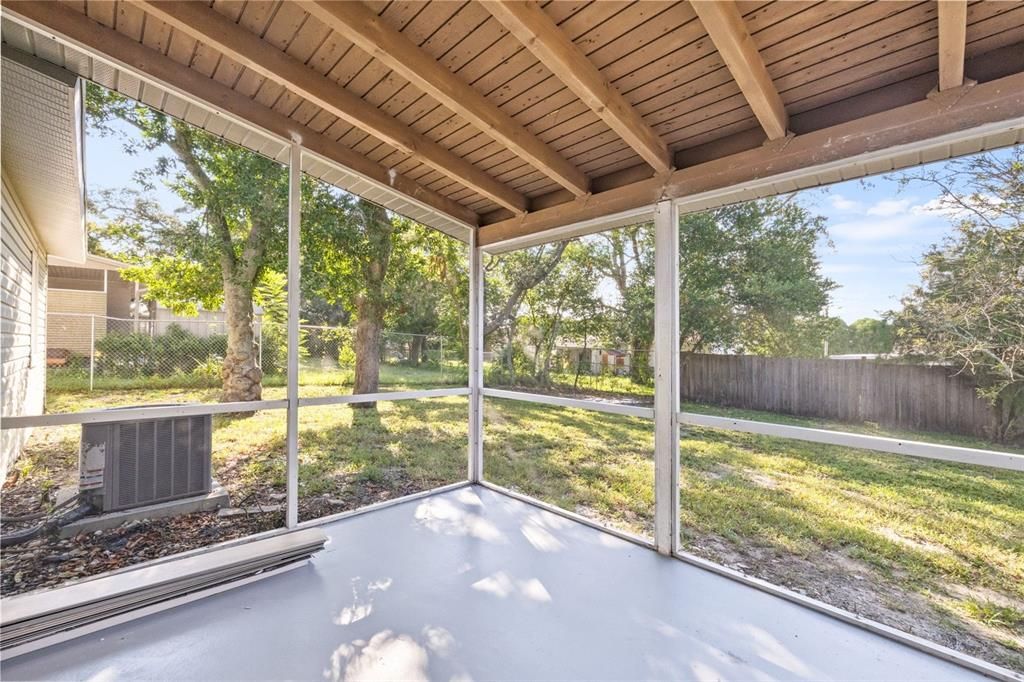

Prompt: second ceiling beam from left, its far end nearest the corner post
[{"left": 134, "top": 0, "right": 527, "bottom": 214}]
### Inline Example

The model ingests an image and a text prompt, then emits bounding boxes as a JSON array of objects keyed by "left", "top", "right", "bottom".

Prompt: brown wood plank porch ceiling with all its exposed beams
[{"left": 4, "top": 0, "right": 1024, "bottom": 241}]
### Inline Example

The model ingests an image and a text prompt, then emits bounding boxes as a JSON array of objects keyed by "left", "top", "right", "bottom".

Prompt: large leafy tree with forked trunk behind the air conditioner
[{"left": 86, "top": 85, "right": 288, "bottom": 401}]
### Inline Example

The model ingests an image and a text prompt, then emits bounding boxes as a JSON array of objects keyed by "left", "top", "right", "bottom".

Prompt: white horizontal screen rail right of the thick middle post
[{"left": 679, "top": 412, "right": 1024, "bottom": 471}]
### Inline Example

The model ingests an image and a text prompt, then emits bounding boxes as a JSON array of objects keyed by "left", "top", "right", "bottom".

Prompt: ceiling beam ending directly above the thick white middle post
[{"left": 483, "top": 0, "right": 672, "bottom": 173}]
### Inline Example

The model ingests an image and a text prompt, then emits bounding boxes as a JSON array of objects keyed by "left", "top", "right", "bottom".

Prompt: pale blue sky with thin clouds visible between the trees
[{"left": 85, "top": 116, "right": 999, "bottom": 323}]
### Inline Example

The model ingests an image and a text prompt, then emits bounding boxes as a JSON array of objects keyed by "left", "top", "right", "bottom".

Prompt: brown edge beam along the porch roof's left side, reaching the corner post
[{"left": 4, "top": 0, "right": 478, "bottom": 225}]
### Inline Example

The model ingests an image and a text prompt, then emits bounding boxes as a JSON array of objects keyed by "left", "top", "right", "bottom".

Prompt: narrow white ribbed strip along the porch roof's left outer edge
[{"left": 0, "top": 16, "right": 472, "bottom": 242}]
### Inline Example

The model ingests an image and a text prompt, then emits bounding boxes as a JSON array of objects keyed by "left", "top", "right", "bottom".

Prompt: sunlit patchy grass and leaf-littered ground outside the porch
[{"left": 3, "top": 368, "right": 1024, "bottom": 670}]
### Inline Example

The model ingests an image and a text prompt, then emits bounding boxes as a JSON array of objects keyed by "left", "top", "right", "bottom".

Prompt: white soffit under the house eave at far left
[{"left": 0, "top": 50, "right": 86, "bottom": 261}]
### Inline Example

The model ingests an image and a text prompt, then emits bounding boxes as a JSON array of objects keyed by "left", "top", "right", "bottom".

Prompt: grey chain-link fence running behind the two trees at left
[{"left": 46, "top": 312, "right": 467, "bottom": 390}]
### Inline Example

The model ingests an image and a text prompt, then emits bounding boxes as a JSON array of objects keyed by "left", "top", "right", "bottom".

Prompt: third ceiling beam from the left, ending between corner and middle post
[{"left": 299, "top": 0, "right": 590, "bottom": 197}]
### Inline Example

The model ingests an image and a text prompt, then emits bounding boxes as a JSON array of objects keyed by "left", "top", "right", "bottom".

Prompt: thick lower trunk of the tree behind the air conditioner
[{"left": 220, "top": 285, "right": 263, "bottom": 402}]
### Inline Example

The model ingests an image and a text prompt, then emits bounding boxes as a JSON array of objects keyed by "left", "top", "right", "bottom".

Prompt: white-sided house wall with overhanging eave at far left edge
[{"left": 0, "top": 45, "right": 86, "bottom": 478}]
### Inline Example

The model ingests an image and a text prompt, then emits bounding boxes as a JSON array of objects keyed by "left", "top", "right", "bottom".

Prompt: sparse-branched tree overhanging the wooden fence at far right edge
[{"left": 893, "top": 146, "right": 1024, "bottom": 438}]
